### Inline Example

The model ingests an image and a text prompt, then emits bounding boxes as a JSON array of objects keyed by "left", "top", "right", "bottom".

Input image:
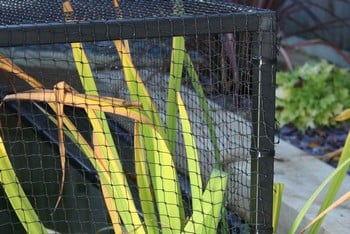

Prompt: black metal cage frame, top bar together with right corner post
[{"left": 0, "top": 0, "right": 277, "bottom": 233}]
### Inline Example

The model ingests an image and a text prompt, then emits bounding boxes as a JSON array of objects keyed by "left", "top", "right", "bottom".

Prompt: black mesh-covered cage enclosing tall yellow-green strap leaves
[{"left": 0, "top": 0, "right": 276, "bottom": 233}]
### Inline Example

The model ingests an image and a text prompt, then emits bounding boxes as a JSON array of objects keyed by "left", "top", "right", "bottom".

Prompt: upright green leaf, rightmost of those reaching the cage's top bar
[{"left": 166, "top": 37, "right": 185, "bottom": 154}]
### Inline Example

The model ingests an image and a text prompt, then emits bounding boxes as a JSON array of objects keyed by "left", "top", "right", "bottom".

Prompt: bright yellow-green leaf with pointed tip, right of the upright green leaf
[{"left": 177, "top": 92, "right": 203, "bottom": 207}]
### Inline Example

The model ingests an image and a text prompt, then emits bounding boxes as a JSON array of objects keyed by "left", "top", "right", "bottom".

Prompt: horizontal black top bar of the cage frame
[{"left": 0, "top": 14, "right": 259, "bottom": 47}]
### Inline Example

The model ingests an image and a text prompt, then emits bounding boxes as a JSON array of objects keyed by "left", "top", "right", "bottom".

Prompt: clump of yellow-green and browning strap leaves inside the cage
[{"left": 0, "top": 1, "right": 228, "bottom": 233}]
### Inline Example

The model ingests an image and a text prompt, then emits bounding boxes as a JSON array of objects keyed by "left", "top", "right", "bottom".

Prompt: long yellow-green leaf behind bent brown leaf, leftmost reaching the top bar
[{"left": 63, "top": 9, "right": 137, "bottom": 227}]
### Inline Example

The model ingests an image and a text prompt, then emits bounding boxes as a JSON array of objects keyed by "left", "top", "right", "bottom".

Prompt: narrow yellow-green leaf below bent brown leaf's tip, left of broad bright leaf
[{"left": 134, "top": 122, "right": 159, "bottom": 233}]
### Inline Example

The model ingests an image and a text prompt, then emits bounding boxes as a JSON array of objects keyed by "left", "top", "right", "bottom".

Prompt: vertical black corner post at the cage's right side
[{"left": 250, "top": 14, "right": 276, "bottom": 233}]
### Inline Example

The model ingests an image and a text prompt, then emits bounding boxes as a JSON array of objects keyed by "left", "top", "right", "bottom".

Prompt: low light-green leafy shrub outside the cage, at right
[{"left": 276, "top": 61, "right": 350, "bottom": 130}]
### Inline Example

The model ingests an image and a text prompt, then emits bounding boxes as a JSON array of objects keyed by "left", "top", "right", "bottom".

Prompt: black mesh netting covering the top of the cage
[{"left": 0, "top": 0, "right": 264, "bottom": 25}]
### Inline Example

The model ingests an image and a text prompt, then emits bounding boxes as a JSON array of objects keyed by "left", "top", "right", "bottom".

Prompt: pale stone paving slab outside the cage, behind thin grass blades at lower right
[{"left": 274, "top": 140, "right": 350, "bottom": 234}]
